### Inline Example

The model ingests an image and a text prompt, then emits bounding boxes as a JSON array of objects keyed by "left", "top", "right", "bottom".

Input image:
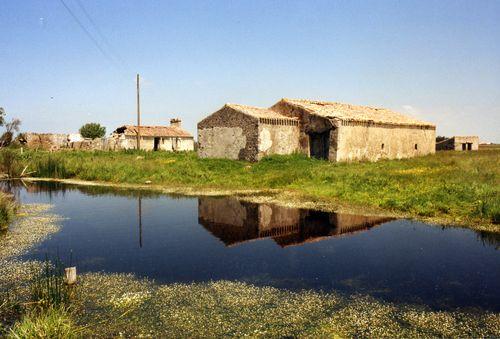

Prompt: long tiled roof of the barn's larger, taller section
[{"left": 281, "top": 99, "right": 435, "bottom": 126}]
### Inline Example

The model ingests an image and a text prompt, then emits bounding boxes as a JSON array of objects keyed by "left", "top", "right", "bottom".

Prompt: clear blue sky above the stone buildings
[{"left": 0, "top": 0, "right": 500, "bottom": 142}]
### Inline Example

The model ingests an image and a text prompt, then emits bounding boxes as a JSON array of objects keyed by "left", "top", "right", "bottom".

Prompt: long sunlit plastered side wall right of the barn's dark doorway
[{"left": 336, "top": 123, "right": 436, "bottom": 161}]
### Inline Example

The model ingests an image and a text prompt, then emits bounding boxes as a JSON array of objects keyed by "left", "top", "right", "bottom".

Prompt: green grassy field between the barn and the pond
[{"left": 3, "top": 149, "right": 500, "bottom": 232}]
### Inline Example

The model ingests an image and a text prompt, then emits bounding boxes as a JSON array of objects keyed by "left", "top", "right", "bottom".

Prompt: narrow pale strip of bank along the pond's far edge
[{"left": 22, "top": 177, "right": 500, "bottom": 234}]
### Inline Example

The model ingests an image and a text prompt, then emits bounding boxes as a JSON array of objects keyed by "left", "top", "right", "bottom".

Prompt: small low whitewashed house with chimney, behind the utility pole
[{"left": 110, "top": 119, "right": 194, "bottom": 151}]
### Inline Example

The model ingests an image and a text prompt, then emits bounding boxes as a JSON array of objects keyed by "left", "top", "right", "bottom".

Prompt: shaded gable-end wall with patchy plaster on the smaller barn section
[{"left": 198, "top": 107, "right": 258, "bottom": 161}]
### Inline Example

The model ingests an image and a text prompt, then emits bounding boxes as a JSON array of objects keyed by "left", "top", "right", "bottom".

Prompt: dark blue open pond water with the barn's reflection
[{"left": 4, "top": 182, "right": 500, "bottom": 312}]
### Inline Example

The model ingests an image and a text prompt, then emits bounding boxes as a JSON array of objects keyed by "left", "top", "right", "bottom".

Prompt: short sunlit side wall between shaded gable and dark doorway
[{"left": 257, "top": 123, "right": 300, "bottom": 160}]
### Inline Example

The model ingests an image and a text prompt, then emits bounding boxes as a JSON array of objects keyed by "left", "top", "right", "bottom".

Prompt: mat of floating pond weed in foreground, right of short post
[{"left": 71, "top": 274, "right": 500, "bottom": 338}]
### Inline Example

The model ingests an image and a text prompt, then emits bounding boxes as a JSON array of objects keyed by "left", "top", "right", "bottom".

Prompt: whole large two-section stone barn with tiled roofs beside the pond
[{"left": 198, "top": 99, "right": 436, "bottom": 161}]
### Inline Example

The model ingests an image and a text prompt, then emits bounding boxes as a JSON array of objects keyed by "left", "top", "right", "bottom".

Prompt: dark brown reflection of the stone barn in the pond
[{"left": 198, "top": 197, "right": 393, "bottom": 247}]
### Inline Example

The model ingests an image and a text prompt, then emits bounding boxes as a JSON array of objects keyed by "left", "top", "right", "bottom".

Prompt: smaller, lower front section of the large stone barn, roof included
[{"left": 198, "top": 104, "right": 299, "bottom": 161}]
